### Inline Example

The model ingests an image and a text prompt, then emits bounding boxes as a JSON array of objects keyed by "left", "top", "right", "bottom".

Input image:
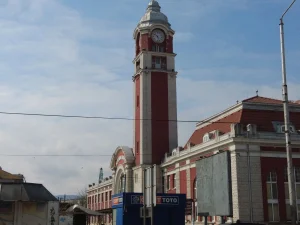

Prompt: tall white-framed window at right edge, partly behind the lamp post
[{"left": 284, "top": 167, "right": 300, "bottom": 220}]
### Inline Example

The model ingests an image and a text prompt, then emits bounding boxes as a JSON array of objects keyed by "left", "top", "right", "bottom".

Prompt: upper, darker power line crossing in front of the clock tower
[{"left": 0, "top": 111, "right": 236, "bottom": 124}]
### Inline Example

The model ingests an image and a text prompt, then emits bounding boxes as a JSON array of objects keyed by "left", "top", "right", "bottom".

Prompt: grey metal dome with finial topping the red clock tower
[{"left": 139, "top": 0, "right": 171, "bottom": 27}]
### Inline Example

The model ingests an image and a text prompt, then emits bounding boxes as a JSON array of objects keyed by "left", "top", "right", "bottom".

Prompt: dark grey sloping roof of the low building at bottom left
[{"left": 0, "top": 183, "right": 58, "bottom": 202}]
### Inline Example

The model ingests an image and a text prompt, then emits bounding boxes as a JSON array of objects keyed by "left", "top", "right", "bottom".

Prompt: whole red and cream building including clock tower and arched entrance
[{"left": 88, "top": 0, "right": 300, "bottom": 224}]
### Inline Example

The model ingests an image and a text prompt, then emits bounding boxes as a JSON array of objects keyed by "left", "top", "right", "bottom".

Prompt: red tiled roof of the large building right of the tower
[{"left": 185, "top": 96, "right": 300, "bottom": 148}]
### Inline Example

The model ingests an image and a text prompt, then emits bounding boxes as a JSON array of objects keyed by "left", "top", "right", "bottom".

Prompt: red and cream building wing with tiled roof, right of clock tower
[{"left": 161, "top": 96, "right": 300, "bottom": 223}]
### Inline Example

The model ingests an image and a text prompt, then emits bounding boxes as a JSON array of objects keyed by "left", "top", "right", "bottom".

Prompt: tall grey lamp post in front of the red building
[{"left": 279, "top": 0, "right": 297, "bottom": 225}]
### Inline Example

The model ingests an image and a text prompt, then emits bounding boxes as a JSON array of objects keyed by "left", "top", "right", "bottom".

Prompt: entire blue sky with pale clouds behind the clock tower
[{"left": 0, "top": 0, "right": 300, "bottom": 194}]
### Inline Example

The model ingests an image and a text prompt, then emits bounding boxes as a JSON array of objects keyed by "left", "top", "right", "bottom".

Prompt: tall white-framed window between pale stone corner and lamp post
[{"left": 267, "top": 171, "right": 279, "bottom": 222}]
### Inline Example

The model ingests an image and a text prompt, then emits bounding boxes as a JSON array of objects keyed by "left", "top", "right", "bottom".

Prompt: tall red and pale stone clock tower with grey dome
[{"left": 133, "top": 0, "right": 178, "bottom": 169}]
